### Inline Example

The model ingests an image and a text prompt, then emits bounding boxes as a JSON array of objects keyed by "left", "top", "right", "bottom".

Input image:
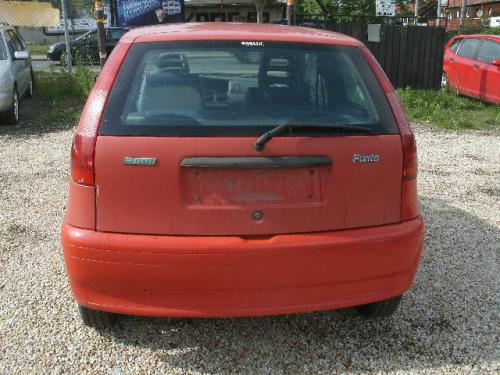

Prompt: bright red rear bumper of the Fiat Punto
[{"left": 62, "top": 217, "right": 424, "bottom": 317}]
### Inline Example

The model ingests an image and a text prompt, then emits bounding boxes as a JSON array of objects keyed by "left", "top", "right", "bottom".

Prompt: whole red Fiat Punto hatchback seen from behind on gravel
[{"left": 62, "top": 24, "right": 424, "bottom": 328}]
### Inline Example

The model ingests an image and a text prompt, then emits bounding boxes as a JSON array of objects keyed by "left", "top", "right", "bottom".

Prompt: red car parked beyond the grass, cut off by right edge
[{"left": 442, "top": 35, "right": 500, "bottom": 104}]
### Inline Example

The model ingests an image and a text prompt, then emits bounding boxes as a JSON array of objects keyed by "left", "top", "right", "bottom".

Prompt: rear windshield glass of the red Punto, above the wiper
[{"left": 100, "top": 41, "right": 397, "bottom": 136}]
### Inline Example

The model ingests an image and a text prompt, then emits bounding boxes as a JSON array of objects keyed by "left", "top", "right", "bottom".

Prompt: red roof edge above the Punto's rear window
[{"left": 121, "top": 22, "right": 362, "bottom": 46}]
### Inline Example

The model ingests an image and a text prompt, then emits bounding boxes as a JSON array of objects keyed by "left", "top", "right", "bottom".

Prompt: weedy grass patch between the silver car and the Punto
[{"left": 21, "top": 70, "right": 97, "bottom": 126}]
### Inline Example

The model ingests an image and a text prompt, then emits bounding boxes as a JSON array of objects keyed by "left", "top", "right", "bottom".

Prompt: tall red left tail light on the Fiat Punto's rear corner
[{"left": 71, "top": 43, "right": 130, "bottom": 186}]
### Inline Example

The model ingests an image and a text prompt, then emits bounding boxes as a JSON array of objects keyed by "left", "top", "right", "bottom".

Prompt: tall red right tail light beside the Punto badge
[{"left": 360, "top": 47, "right": 419, "bottom": 221}]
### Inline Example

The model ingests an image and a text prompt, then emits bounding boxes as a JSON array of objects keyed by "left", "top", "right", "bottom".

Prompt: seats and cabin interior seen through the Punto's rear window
[{"left": 122, "top": 49, "right": 376, "bottom": 125}]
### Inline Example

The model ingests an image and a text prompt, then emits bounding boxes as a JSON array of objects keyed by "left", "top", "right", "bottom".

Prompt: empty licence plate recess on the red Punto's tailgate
[{"left": 181, "top": 158, "right": 331, "bottom": 207}]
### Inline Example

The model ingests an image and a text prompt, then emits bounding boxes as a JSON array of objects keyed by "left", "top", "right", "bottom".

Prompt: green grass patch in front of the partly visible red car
[{"left": 398, "top": 89, "right": 500, "bottom": 129}]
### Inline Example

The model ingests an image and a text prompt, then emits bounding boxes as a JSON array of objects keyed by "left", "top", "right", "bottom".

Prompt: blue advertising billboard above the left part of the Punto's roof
[{"left": 117, "top": 0, "right": 184, "bottom": 26}]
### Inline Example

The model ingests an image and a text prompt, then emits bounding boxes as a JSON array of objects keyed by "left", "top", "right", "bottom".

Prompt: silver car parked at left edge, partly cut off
[{"left": 0, "top": 25, "right": 33, "bottom": 124}]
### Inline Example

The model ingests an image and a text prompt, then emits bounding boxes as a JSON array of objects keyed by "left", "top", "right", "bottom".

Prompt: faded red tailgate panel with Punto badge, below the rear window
[{"left": 95, "top": 135, "right": 402, "bottom": 235}]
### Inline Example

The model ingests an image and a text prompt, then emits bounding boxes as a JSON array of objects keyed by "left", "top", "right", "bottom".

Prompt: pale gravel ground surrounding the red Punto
[{"left": 0, "top": 118, "right": 500, "bottom": 375}]
